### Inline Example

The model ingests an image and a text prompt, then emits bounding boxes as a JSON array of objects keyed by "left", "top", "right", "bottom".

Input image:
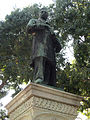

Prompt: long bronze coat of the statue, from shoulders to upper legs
[{"left": 27, "top": 19, "right": 61, "bottom": 66}]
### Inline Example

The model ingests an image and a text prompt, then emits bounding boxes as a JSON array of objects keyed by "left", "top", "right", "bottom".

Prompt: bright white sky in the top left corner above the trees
[{"left": 0, "top": 0, "right": 53, "bottom": 20}]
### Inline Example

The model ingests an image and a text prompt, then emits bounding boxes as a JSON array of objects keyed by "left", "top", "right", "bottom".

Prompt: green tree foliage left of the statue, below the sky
[{"left": 0, "top": 4, "right": 39, "bottom": 94}]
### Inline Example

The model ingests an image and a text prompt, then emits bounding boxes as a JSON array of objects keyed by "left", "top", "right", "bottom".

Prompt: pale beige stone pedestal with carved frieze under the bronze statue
[{"left": 6, "top": 83, "right": 82, "bottom": 120}]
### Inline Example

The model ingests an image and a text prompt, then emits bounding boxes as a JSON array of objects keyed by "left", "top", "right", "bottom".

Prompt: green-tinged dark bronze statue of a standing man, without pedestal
[{"left": 27, "top": 9, "right": 61, "bottom": 86}]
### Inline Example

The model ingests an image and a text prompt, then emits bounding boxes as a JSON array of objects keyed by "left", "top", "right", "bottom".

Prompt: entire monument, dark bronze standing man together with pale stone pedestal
[{"left": 6, "top": 9, "right": 82, "bottom": 120}]
